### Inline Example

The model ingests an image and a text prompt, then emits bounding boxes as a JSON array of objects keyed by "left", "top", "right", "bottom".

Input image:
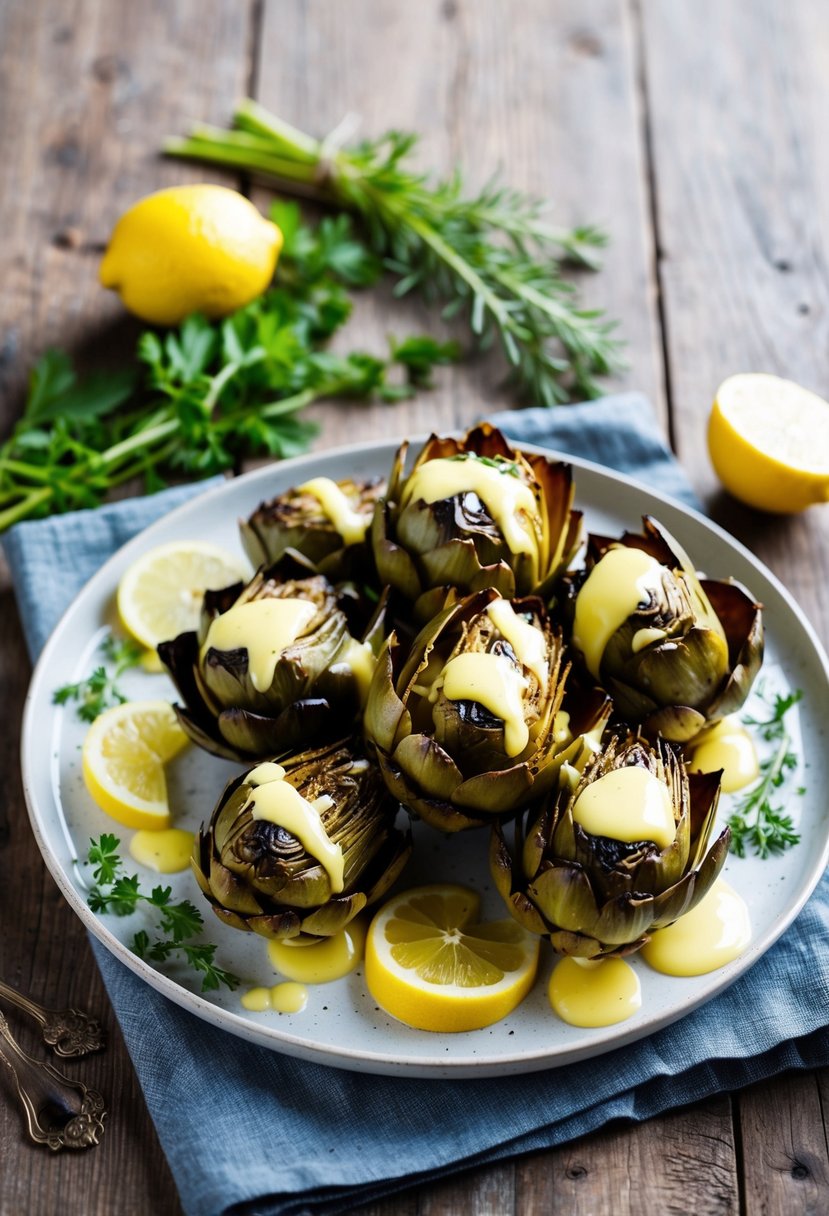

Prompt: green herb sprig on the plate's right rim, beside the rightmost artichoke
[{"left": 727, "top": 688, "right": 803, "bottom": 857}]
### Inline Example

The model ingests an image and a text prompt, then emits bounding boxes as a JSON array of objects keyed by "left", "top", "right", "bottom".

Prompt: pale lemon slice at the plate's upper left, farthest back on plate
[{"left": 118, "top": 540, "right": 244, "bottom": 651}]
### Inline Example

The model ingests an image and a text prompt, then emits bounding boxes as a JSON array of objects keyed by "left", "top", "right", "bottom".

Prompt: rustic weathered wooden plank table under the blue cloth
[{"left": 0, "top": 0, "right": 829, "bottom": 1216}]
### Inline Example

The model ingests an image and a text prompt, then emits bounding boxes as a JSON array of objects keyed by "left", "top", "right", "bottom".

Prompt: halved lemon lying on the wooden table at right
[{"left": 707, "top": 372, "right": 829, "bottom": 514}]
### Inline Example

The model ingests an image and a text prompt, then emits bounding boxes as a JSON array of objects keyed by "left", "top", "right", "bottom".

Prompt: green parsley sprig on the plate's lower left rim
[{"left": 86, "top": 832, "right": 241, "bottom": 992}]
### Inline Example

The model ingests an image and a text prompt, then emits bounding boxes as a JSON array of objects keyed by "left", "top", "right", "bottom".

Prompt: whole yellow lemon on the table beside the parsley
[{"left": 100, "top": 184, "right": 282, "bottom": 325}]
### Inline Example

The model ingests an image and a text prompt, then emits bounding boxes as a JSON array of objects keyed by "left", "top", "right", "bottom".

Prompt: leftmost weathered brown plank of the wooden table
[{"left": 0, "top": 0, "right": 253, "bottom": 1216}]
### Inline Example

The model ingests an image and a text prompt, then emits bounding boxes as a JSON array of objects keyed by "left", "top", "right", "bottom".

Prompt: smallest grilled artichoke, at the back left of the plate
[{"left": 239, "top": 477, "right": 384, "bottom": 582}]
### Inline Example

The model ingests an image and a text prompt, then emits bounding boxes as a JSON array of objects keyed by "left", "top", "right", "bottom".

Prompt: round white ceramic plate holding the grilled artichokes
[{"left": 22, "top": 443, "right": 829, "bottom": 1077}]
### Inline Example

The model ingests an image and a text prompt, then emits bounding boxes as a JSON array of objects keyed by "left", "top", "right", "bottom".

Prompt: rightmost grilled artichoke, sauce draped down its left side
[{"left": 570, "top": 517, "right": 763, "bottom": 743}]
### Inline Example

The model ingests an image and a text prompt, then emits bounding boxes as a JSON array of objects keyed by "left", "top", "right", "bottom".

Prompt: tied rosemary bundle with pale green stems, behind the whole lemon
[{"left": 164, "top": 100, "right": 620, "bottom": 405}]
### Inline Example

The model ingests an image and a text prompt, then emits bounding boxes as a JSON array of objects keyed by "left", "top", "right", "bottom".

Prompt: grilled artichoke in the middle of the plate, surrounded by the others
[{"left": 363, "top": 590, "right": 607, "bottom": 832}]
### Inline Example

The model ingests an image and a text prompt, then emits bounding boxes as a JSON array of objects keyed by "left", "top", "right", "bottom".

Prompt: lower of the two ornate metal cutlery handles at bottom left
[{"left": 0, "top": 1013, "right": 107, "bottom": 1153}]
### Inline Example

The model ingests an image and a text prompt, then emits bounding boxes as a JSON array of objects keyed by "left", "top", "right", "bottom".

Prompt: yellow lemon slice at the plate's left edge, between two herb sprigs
[{"left": 81, "top": 700, "right": 187, "bottom": 829}]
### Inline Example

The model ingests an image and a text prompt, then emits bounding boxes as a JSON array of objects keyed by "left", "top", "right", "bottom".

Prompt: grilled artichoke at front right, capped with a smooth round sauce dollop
[{"left": 490, "top": 737, "right": 731, "bottom": 958}]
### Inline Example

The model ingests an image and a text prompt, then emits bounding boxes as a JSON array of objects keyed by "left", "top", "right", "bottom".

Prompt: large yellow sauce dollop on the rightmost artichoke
[{"left": 573, "top": 545, "right": 664, "bottom": 680}]
